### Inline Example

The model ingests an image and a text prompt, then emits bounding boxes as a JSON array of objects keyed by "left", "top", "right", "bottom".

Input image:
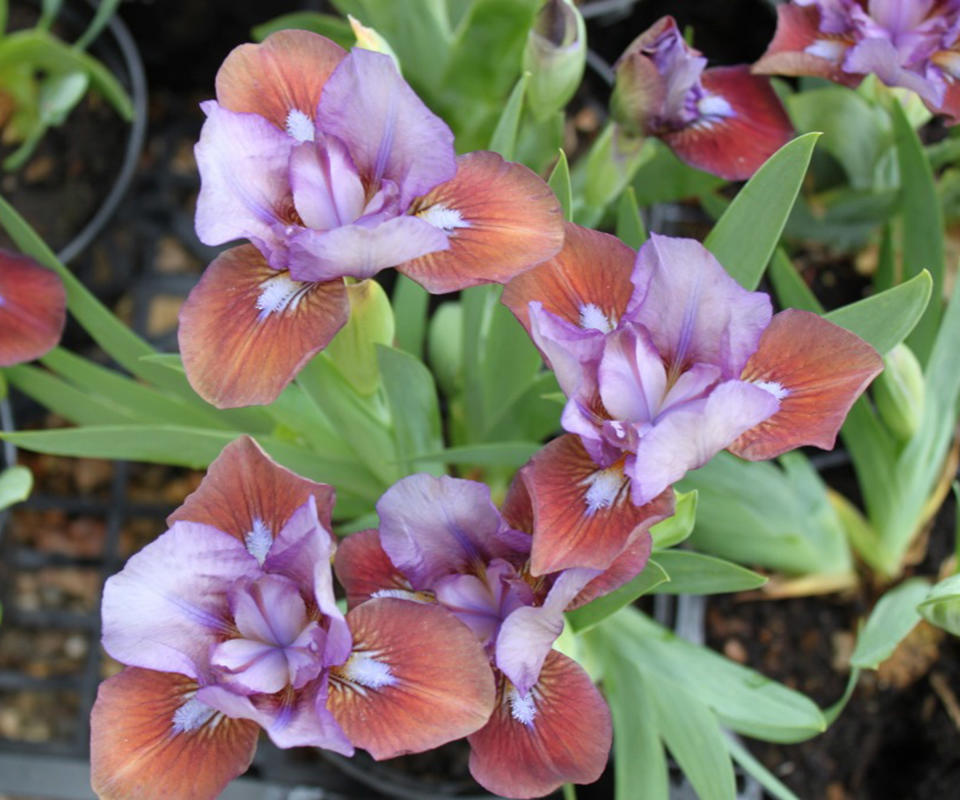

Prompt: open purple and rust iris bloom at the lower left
[{"left": 91, "top": 439, "right": 494, "bottom": 800}]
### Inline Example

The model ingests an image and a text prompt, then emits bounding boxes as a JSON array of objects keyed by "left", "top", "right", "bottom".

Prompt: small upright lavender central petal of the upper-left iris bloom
[{"left": 290, "top": 136, "right": 366, "bottom": 230}]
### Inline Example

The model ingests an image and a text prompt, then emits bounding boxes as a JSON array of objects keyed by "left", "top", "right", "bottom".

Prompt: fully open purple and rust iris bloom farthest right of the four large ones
[{"left": 503, "top": 225, "right": 883, "bottom": 575}]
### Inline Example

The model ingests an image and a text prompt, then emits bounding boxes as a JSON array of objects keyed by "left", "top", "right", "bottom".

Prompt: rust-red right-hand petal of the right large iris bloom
[{"left": 729, "top": 309, "right": 883, "bottom": 461}]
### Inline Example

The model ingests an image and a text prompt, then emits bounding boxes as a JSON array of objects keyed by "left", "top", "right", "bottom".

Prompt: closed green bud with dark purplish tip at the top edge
[{"left": 523, "top": 0, "right": 587, "bottom": 121}]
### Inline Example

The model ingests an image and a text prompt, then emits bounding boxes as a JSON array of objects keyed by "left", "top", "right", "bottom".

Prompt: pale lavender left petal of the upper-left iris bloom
[{"left": 195, "top": 100, "right": 295, "bottom": 269}]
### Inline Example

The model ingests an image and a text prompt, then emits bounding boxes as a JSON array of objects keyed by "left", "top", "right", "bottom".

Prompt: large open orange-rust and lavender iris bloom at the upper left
[{"left": 180, "top": 31, "right": 563, "bottom": 407}]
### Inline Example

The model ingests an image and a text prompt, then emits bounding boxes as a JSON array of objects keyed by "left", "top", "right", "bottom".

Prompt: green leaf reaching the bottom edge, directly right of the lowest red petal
[{"left": 603, "top": 651, "right": 670, "bottom": 800}]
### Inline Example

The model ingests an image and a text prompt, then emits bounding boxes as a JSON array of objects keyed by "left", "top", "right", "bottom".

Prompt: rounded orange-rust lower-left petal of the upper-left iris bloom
[{"left": 179, "top": 245, "right": 350, "bottom": 408}]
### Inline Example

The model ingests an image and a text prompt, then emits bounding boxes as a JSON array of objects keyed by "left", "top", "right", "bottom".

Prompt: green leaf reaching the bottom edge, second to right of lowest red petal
[{"left": 647, "top": 672, "right": 737, "bottom": 800}]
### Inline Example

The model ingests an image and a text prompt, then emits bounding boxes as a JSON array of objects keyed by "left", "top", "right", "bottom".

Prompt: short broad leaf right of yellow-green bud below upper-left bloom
[{"left": 377, "top": 344, "right": 443, "bottom": 474}]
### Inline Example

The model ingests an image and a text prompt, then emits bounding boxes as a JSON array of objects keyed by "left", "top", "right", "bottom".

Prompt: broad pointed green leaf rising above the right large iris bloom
[{"left": 704, "top": 133, "right": 820, "bottom": 289}]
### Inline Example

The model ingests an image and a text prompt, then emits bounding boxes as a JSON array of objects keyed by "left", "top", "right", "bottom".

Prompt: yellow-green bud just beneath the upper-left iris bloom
[{"left": 326, "top": 280, "right": 394, "bottom": 395}]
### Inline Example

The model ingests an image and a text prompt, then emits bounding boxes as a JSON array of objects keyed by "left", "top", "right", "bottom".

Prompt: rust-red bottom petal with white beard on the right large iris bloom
[{"left": 527, "top": 435, "right": 673, "bottom": 575}]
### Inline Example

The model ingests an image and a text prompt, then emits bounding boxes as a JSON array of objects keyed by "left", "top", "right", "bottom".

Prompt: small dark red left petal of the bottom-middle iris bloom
[{"left": 333, "top": 530, "right": 417, "bottom": 608}]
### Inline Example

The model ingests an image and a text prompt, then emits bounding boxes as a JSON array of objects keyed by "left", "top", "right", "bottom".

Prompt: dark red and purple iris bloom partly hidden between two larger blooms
[{"left": 335, "top": 476, "right": 660, "bottom": 797}]
